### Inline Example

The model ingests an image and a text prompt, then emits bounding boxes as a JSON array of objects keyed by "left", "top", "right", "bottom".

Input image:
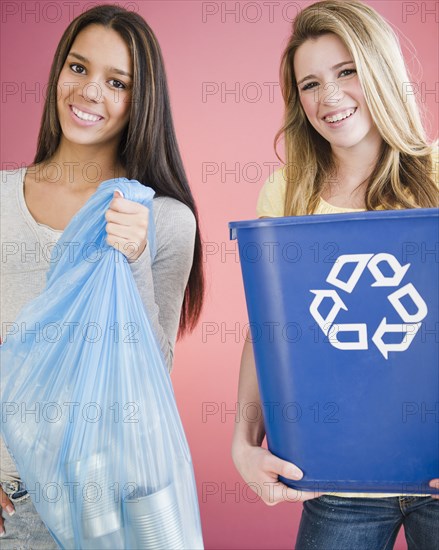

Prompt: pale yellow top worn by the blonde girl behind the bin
[{"left": 256, "top": 152, "right": 439, "bottom": 498}]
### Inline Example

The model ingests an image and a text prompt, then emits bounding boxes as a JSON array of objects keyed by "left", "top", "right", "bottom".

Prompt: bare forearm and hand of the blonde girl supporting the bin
[{"left": 232, "top": 335, "right": 319, "bottom": 505}]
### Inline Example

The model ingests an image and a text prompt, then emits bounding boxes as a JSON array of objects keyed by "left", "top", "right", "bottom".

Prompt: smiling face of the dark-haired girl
[{"left": 57, "top": 24, "right": 133, "bottom": 148}]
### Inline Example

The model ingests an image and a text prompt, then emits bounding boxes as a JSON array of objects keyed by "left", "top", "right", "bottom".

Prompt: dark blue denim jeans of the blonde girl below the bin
[{"left": 296, "top": 495, "right": 439, "bottom": 550}]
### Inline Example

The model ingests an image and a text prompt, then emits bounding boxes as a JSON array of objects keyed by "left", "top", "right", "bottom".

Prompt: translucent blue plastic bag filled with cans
[{"left": 0, "top": 178, "right": 203, "bottom": 550}]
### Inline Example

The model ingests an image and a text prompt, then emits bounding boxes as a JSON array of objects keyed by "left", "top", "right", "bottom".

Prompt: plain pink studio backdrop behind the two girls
[{"left": 1, "top": 0, "right": 439, "bottom": 550}]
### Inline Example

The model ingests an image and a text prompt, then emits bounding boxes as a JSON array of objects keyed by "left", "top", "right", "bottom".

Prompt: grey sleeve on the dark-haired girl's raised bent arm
[{"left": 130, "top": 197, "right": 196, "bottom": 371}]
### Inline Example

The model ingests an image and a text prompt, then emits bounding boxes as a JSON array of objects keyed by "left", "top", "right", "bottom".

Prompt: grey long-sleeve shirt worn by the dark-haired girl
[{"left": 0, "top": 168, "right": 196, "bottom": 481}]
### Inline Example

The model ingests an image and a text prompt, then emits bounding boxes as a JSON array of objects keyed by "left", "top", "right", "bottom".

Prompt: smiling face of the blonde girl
[{"left": 294, "top": 34, "right": 381, "bottom": 155}]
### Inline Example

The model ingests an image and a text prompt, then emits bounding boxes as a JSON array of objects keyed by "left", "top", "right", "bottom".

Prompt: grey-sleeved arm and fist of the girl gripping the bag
[{"left": 106, "top": 193, "right": 196, "bottom": 371}]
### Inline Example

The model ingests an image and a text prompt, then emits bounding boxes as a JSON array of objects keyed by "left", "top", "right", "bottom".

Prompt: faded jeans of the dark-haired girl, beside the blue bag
[{"left": 0, "top": 482, "right": 58, "bottom": 550}]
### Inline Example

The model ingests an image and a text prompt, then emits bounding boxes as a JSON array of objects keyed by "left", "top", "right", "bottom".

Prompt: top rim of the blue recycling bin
[{"left": 229, "top": 208, "right": 439, "bottom": 240}]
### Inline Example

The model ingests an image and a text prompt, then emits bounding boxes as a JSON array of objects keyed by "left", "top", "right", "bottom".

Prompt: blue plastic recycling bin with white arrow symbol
[{"left": 229, "top": 208, "right": 439, "bottom": 494}]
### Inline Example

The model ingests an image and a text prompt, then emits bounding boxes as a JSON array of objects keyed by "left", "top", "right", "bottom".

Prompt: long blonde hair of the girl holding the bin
[{"left": 275, "top": 0, "right": 438, "bottom": 216}]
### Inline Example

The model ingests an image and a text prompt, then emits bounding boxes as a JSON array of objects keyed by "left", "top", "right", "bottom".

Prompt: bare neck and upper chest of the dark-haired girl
[{"left": 36, "top": 138, "right": 125, "bottom": 190}]
